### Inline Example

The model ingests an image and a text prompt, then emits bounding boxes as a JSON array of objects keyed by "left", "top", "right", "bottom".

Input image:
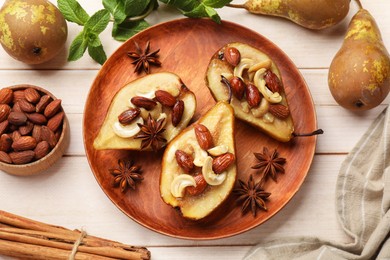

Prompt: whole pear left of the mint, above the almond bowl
[{"left": 0, "top": 0, "right": 68, "bottom": 64}]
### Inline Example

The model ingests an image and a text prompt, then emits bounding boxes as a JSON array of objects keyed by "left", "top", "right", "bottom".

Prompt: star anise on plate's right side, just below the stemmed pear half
[{"left": 252, "top": 147, "right": 286, "bottom": 182}]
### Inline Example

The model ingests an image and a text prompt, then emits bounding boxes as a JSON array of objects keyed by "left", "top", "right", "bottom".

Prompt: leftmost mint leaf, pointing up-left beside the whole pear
[{"left": 57, "top": 0, "right": 89, "bottom": 25}]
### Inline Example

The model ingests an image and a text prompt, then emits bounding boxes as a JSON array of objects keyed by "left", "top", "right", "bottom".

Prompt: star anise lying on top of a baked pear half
[{"left": 135, "top": 114, "right": 167, "bottom": 151}]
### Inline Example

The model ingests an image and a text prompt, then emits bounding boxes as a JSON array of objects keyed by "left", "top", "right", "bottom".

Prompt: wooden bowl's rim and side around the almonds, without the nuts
[{"left": 0, "top": 84, "right": 70, "bottom": 176}]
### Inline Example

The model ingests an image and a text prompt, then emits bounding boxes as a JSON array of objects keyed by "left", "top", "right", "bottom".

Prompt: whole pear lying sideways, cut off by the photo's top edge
[{"left": 229, "top": 0, "right": 350, "bottom": 30}]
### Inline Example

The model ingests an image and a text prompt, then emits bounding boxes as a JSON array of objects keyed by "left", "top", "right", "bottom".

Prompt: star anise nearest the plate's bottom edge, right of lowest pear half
[{"left": 234, "top": 174, "right": 271, "bottom": 217}]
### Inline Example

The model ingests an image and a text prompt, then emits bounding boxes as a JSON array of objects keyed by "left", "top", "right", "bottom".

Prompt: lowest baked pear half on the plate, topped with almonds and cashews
[{"left": 160, "top": 102, "right": 237, "bottom": 220}]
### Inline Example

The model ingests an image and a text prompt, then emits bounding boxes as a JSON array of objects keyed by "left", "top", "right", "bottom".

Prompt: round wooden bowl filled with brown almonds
[{"left": 0, "top": 84, "right": 70, "bottom": 176}]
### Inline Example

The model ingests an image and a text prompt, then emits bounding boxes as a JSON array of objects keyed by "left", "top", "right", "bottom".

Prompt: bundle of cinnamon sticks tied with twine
[{"left": 0, "top": 210, "right": 150, "bottom": 260}]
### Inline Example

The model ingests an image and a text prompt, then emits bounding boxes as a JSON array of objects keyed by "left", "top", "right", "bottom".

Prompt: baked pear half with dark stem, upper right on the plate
[{"left": 206, "top": 42, "right": 294, "bottom": 142}]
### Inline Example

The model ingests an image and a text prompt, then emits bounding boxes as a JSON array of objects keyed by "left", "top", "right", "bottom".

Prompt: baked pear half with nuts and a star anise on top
[{"left": 93, "top": 72, "right": 196, "bottom": 150}]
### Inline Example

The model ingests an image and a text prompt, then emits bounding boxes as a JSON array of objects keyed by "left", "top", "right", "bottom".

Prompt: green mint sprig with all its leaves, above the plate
[{"left": 57, "top": 0, "right": 232, "bottom": 64}]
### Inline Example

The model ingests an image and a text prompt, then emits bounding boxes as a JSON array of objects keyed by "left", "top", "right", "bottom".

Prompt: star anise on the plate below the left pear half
[{"left": 109, "top": 159, "right": 144, "bottom": 192}]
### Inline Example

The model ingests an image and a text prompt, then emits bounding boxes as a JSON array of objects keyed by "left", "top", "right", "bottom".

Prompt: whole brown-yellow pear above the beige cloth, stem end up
[{"left": 328, "top": 8, "right": 390, "bottom": 110}]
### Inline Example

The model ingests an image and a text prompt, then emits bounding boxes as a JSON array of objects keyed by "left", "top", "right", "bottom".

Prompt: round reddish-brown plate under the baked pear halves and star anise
[{"left": 83, "top": 19, "right": 317, "bottom": 239}]
